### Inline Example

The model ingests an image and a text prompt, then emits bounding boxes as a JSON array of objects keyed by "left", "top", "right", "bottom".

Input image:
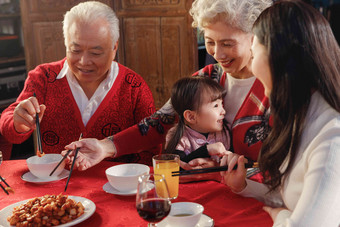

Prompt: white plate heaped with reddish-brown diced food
[{"left": 0, "top": 194, "right": 96, "bottom": 227}]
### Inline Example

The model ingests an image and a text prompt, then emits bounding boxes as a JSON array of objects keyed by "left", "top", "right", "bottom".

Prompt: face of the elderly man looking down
[{"left": 66, "top": 19, "right": 118, "bottom": 86}]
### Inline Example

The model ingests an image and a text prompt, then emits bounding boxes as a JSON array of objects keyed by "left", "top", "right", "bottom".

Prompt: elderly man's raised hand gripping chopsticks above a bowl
[{"left": 13, "top": 97, "right": 46, "bottom": 133}]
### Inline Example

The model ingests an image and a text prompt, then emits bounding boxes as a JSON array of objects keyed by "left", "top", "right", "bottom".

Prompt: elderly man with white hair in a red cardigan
[{"left": 0, "top": 1, "right": 155, "bottom": 163}]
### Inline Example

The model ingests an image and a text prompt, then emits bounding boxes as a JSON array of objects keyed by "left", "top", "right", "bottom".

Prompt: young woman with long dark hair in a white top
[{"left": 221, "top": 0, "right": 340, "bottom": 227}]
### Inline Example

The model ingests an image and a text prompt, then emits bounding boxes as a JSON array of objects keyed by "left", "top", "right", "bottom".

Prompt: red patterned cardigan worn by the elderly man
[{"left": 0, "top": 59, "right": 155, "bottom": 163}]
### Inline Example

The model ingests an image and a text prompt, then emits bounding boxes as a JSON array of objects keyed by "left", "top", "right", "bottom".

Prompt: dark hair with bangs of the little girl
[{"left": 165, "top": 76, "right": 225, "bottom": 153}]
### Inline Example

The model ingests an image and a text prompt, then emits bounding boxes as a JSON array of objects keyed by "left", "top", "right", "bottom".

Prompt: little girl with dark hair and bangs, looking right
[{"left": 165, "top": 76, "right": 230, "bottom": 162}]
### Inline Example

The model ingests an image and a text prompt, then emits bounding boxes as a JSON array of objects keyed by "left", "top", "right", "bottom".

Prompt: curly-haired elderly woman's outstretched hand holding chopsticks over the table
[{"left": 61, "top": 138, "right": 116, "bottom": 171}]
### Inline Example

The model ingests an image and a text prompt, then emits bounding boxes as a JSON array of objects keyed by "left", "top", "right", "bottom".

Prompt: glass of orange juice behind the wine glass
[{"left": 152, "top": 154, "right": 180, "bottom": 199}]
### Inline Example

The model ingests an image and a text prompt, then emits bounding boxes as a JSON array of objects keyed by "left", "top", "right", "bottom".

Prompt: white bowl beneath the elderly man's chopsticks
[{"left": 26, "top": 154, "right": 65, "bottom": 179}]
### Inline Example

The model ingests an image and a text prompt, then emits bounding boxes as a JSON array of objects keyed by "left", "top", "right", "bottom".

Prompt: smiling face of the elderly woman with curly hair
[{"left": 204, "top": 21, "right": 252, "bottom": 78}]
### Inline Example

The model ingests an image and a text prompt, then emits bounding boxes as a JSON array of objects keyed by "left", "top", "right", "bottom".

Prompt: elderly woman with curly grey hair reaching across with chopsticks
[{"left": 63, "top": 0, "right": 272, "bottom": 172}]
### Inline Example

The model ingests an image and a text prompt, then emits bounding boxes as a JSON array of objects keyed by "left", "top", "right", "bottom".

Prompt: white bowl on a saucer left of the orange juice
[{"left": 105, "top": 163, "right": 150, "bottom": 192}]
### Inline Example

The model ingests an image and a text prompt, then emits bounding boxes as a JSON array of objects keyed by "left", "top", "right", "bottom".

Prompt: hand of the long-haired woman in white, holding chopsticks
[{"left": 220, "top": 153, "right": 247, "bottom": 192}]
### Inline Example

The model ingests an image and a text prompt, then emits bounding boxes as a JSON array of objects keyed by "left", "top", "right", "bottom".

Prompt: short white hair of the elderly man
[{"left": 63, "top": 1, "right": 119, "bottom": 47}]
